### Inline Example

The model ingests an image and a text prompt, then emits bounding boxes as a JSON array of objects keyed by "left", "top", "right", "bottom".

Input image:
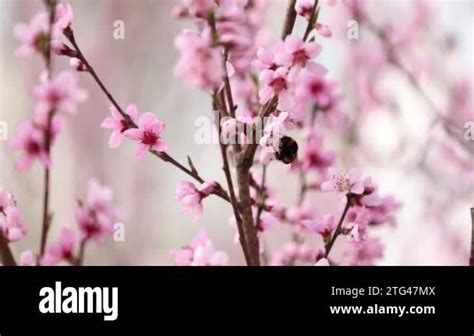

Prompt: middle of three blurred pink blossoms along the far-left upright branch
[{"left": 33, "top": 71, "right": 87, "bottom": 114}]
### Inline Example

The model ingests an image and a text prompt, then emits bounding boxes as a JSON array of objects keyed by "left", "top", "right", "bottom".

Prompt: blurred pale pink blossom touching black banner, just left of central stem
[{"left": 170, "top": 230, "right": 229, "bottom": 266}]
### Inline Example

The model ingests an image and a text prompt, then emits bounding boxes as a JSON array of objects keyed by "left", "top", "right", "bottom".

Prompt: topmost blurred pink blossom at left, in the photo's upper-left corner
[{"left": 13, "top": 13, "right": 58, "bottom": 58}]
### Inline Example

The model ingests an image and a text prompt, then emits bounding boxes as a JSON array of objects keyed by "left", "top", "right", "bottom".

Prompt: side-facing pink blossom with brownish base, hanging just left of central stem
[{"left": 176, "top": 181, "right": 219, "bottom": 223}]
